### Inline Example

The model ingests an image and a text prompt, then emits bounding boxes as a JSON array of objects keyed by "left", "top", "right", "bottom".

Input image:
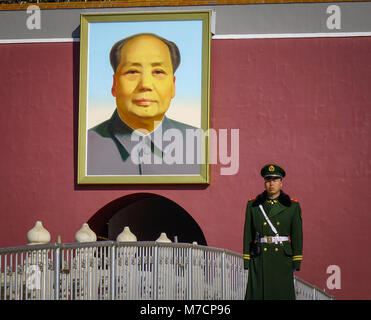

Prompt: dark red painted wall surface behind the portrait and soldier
[{"left": 0, "top": 37, "right": 371, "bottom": 299}]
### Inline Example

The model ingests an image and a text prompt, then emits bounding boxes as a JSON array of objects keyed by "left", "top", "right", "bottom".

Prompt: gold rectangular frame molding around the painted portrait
[{"left": 77, "top": 10, "right": 211, "bottom": 184}]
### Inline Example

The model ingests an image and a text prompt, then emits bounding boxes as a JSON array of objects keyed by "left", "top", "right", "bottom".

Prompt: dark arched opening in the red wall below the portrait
[{"left": 88, "top": 193, "right": 207, "bottom": 245}]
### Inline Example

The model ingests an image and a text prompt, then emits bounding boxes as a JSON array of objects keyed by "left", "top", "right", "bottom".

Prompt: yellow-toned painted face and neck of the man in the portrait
[{"left": 112, "top": 35, "right": 175, "bottom": 129}]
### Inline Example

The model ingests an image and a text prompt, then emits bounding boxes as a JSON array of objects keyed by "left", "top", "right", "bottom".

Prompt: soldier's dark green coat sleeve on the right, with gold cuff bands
[{"left": 291, "top": 203, "right": 303, "bottom": 271}]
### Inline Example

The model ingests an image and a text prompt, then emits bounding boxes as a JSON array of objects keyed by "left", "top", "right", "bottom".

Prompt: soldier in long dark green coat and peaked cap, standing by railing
[{"left": 243, "top": 164, "right": 303, "bottom": 300}]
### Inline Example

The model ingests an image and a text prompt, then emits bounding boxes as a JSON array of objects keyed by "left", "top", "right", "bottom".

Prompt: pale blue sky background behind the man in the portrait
[{"left": 87, "top": 20, "right": 202, "bottom": 128}]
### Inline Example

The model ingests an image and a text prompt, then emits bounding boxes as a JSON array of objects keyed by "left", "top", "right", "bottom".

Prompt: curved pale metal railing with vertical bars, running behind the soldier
[{"left": 0, "top": 241, "right": 331, "bottom": 300}]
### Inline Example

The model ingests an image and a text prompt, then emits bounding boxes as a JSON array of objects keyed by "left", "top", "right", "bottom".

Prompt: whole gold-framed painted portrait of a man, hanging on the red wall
[{"left": 77, "top": 11, "right": 211, "bottom": 184}]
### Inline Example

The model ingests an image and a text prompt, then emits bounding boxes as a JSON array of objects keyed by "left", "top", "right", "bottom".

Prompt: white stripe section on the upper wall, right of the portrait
[{"left": 212, "top": 32, "right": 371, "bottom": 40}]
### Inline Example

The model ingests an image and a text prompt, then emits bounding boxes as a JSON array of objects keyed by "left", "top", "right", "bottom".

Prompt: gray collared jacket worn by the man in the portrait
[{"left": 87, "top": 110, "right": 201, "bottom": 175}]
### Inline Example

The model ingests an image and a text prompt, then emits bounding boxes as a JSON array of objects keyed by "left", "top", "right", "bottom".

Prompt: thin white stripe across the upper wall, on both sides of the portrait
[{"left": 0, "top": 32, "right": 371, "bottom": 44}]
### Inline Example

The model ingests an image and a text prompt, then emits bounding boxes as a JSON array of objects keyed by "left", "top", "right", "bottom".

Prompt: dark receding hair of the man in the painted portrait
[{"left": 110, "top": 33, "right": 180, "bottom": 73}]
